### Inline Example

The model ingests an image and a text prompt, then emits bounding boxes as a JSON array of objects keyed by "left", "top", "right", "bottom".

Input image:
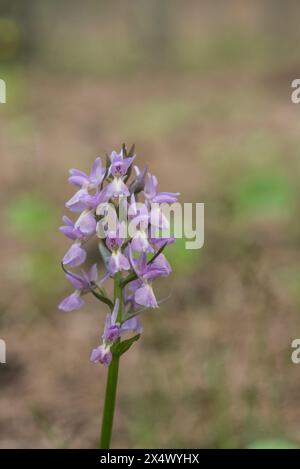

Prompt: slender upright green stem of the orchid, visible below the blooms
[{"left": 100, "top": 273, "right": 122, "bottom": 449}]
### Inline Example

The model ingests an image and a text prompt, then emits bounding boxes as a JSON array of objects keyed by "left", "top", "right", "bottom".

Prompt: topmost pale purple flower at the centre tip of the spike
[{"left": 105, "top": 150, "right": 135, "bottom": 199}]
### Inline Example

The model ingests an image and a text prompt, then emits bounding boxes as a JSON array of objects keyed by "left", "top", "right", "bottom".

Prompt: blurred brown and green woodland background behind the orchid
[{"left": 0, "top": 0, "right": 300, "bottom": 448}]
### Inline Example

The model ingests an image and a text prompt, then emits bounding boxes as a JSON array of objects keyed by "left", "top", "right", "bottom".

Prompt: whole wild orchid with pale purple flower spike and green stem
[{"left": 59, "top": 145, "right": 179, "bottom": 449}]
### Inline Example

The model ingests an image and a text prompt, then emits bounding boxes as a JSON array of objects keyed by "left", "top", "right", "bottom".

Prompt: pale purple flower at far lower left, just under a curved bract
[{"left": 59, "top": 264, "right": 98, "bottom": 311}]
